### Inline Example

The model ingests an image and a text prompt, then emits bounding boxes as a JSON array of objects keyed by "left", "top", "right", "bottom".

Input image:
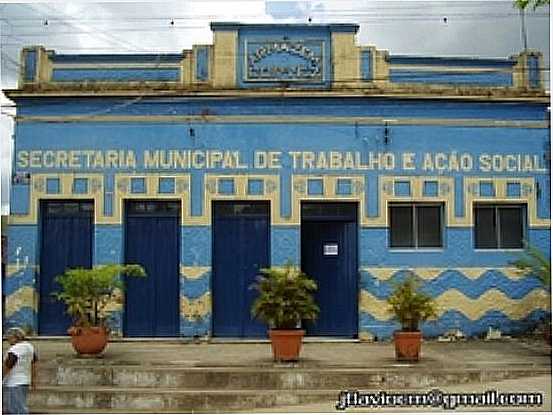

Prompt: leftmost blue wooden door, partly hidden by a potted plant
[{"left": 38, "top": 201, "right": 94, "bottom": 336}]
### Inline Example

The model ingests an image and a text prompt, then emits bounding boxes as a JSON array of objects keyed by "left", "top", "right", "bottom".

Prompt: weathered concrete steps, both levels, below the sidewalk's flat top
[{"left": 30, "top": 360, "right": 551, "bottom": 413}]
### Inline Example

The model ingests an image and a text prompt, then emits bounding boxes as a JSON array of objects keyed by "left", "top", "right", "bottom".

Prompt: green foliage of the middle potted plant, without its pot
[{"left": 251, "top": 264, "right": 319, "bottom": 329}]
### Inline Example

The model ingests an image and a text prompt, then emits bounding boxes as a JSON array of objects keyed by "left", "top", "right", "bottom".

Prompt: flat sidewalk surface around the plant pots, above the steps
[{"left": 17, "top": 339, "right": 551, "bottom": 370}]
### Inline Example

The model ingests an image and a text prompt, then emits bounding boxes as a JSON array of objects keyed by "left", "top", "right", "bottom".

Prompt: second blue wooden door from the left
[{"left": 123, "top": 201, "right": 180, "bottom": 337}]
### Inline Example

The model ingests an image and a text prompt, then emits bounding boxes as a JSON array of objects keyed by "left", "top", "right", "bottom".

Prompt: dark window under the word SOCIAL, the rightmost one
[{"left": 474, "top": 203, "right": 526, "bottom": 249}]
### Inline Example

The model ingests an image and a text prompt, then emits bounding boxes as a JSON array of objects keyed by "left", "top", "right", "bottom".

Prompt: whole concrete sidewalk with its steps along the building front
[{"left": 4, "top": 338, "right": 551, "bottom": 413}]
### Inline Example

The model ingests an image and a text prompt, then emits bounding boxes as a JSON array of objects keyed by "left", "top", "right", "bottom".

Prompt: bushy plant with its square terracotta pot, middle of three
[{"left": 251, "top": 264, "right": 319, "bottom": 361}]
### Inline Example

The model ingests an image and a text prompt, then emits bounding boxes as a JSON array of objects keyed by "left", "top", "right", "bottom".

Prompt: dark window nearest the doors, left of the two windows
[{"left": 389, "top": 203, "right": 443, "bottom": 248}]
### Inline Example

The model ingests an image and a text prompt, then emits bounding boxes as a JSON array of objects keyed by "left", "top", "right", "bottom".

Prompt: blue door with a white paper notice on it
[{"left": 301, "top": 203, "right": 358, "bottom": 337}]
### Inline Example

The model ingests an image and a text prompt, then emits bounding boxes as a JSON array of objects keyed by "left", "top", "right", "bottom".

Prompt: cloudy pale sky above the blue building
[{"left": 0, "top": 0, "right": 550, "bottom": 214}]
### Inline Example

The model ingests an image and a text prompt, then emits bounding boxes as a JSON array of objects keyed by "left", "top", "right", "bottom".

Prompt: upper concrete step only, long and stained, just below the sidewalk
[{"left": 37, "top": 364, "right": 550, "bottom": 390}]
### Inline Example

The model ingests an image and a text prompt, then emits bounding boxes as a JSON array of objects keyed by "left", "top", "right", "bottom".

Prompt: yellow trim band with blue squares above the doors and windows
[{"left": 10, "top": 173, "right": 551, "bottom": 228}]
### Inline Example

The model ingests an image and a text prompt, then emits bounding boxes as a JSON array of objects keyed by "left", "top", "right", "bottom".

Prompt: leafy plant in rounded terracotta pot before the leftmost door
[{"left": 54, "top": 264, "right": 146, "bottom": 354}]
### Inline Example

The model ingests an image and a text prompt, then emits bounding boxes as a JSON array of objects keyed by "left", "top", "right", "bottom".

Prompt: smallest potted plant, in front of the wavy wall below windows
[{"left": 388, "top": 273, "right": 436, "bottom": 361}]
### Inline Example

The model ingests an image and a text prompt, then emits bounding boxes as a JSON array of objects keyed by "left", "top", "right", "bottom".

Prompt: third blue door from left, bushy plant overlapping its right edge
[{"left": 212, "top": 202, "right": 269, "bottom": 337}]
